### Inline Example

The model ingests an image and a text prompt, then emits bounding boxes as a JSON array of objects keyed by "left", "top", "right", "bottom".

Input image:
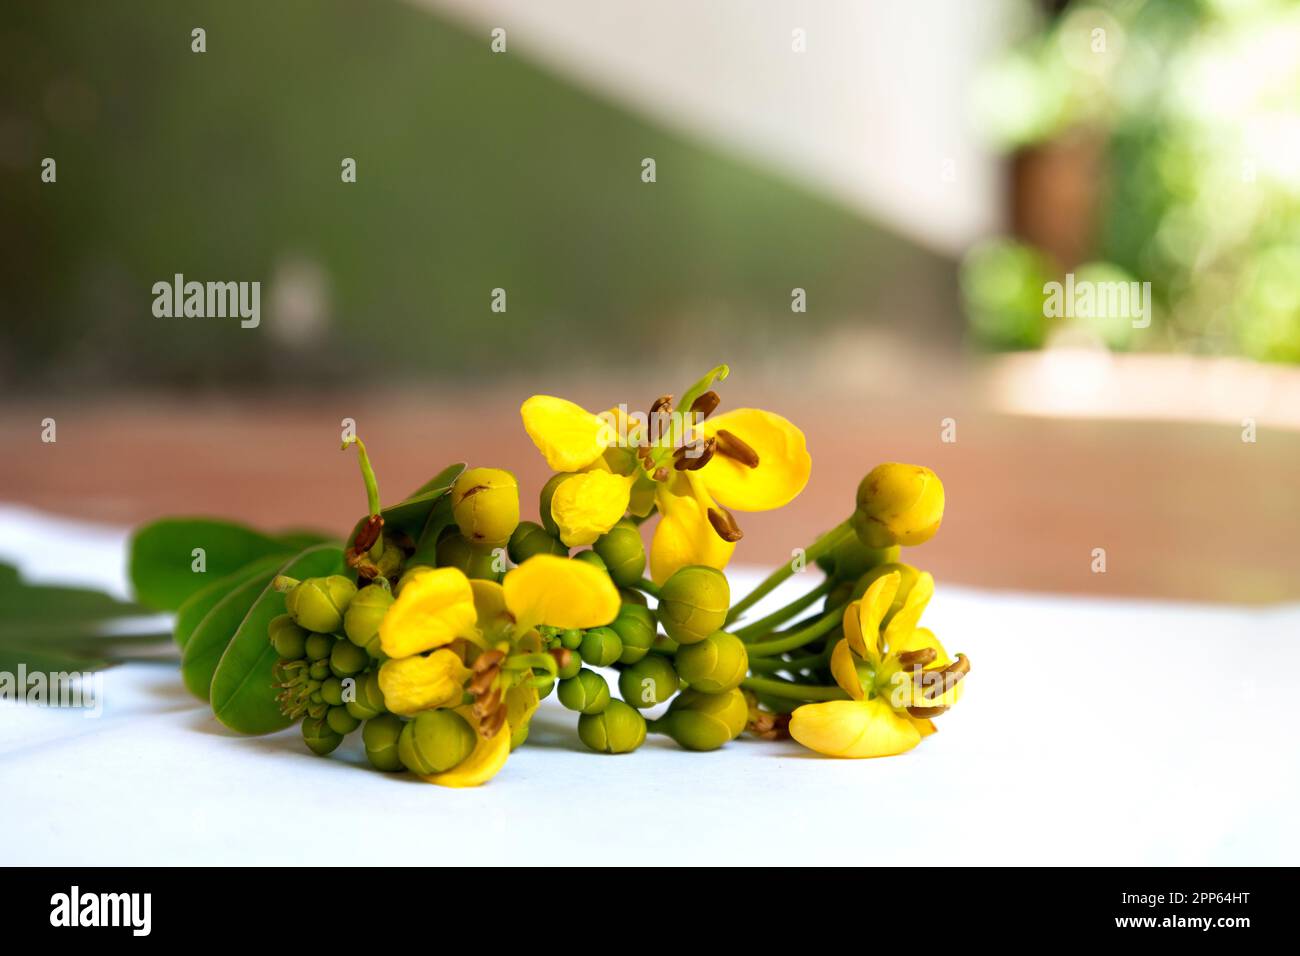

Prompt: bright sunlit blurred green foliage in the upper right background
[{"left": 962, "top": 0, "right": 1300, "bottom": 362}]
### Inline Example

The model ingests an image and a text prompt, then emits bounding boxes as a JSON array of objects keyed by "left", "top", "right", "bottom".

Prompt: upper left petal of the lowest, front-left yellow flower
[{"left": 380, "top": 567, "right": 478, "bottom": 657}]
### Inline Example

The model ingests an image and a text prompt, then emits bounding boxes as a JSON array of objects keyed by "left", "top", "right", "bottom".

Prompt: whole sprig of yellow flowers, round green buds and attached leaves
[{"left": 131, "top": 365, "right": 970, "bottom": 787}]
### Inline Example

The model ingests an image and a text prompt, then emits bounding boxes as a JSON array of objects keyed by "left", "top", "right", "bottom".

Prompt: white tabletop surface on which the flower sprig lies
[{"left": 0, "top": 507, "right": 1300, "bottom": 866}]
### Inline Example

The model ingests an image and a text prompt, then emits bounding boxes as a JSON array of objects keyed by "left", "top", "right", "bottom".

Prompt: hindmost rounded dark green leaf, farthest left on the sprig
[{"left": 129, "top": 518, "right": 301, "bottom": 611}]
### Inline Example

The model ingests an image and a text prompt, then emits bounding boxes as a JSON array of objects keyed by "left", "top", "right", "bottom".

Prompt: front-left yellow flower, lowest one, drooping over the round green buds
[{"left": 380, "top": 554, "right": 620, "bottom": 787}]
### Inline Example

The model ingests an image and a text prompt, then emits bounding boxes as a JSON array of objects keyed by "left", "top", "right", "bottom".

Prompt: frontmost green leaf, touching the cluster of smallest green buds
[{"left": 212, "top": 545, "right": 343, "bottom": 734}]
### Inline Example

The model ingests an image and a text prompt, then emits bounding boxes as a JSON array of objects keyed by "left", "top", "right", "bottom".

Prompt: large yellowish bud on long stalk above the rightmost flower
[{"left": 852, "top": 462, "right": 944, "bottom": 548}]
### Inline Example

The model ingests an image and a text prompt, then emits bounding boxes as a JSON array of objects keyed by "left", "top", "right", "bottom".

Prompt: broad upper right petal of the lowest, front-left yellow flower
[{"left": 503, "top": 554, "right": 619, "bottom": 631}]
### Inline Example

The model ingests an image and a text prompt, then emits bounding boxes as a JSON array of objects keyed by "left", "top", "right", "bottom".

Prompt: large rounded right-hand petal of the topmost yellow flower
[{"left": 699, "top": 408, "right": 813, "bottom": 511}]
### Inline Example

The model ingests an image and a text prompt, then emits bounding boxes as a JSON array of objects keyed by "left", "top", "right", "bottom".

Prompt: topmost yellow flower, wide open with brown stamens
[{"left": 520, "top": 365, "right": 813, "bottom": 583}]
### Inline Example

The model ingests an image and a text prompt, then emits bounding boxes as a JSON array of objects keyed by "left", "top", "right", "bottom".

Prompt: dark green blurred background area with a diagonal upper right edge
[{"left": 0, "top": 0, "right": 956, "bottom": 385}]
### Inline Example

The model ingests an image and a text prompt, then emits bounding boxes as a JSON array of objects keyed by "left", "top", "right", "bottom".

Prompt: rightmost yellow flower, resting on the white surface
[{"left": 790, "top": 571, "right": 970, "bottom": 757}]
